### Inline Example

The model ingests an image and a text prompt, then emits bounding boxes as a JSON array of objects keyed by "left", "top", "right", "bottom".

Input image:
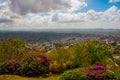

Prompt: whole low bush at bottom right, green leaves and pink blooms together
[{"left": 60, "top": 65, "right": 120, "bottom": 80}]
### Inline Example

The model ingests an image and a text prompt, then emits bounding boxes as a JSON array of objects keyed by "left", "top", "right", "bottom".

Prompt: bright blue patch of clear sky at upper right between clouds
[{"left": 75, "top": 0, "right": 120, "bottom": 13}]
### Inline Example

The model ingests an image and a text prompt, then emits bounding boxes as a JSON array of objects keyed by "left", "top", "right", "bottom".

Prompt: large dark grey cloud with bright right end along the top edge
[{"left": 9, "top": 0, "right": 87, "bottom": 15}]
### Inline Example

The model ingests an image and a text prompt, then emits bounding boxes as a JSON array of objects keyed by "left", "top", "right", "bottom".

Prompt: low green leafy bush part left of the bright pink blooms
[{"left": 60, "top": 69, "right": 87, "bottom": 80}]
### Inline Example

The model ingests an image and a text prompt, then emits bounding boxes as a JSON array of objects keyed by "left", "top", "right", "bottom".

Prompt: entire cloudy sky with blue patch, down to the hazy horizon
[{"left": 0, "top": 0, "right": 120, "bottom": 30}]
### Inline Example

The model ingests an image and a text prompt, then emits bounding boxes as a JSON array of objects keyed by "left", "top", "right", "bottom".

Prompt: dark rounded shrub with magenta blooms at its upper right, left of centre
[{"left": 21, "top": 55, "right": 49, "bottom": 76}]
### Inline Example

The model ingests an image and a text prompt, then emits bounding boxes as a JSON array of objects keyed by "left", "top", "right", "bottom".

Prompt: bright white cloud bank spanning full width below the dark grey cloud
[{"left": 0, "top": 0, "right": 120, "bottom": 30}]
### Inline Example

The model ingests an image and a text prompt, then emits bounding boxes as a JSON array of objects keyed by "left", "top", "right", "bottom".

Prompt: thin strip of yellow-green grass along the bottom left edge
[{"left": 0, "top": 75, "right": 59, "bottom": 80}]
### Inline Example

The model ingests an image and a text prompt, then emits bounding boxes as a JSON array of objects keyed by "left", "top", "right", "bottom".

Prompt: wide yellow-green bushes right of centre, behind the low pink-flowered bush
[{"left": 48, "top": 41, "right": 114, "bottom": 73}]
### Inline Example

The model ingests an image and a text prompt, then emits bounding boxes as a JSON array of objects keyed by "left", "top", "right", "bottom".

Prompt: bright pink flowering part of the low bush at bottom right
[{"left": 83, "top": 65, "right": 117, "bottom": 80}]
